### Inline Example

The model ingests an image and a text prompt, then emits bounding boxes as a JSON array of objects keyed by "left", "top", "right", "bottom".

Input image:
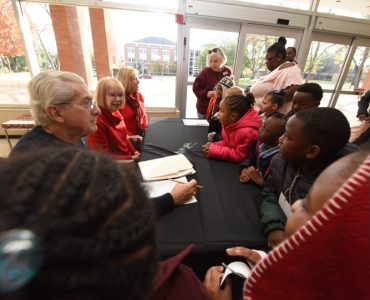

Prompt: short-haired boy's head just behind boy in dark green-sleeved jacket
[{"left": 286, "top": 82, "right": 324, "bottom": 119}]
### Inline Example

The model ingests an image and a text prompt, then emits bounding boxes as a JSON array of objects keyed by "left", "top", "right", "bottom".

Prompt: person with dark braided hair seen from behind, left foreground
[{"left": 0, "top": 147, "right": 207, "bottom": 300}]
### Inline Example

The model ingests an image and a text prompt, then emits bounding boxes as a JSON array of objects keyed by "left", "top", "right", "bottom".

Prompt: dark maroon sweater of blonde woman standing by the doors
[{"left": 193, "top": 66, "right": 232, "bottom": 114}]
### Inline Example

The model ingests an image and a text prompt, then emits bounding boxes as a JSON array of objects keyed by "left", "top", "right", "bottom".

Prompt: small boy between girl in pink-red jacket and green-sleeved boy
[{"left": 239, "top": 112, "right": 285, "bottom": 186}]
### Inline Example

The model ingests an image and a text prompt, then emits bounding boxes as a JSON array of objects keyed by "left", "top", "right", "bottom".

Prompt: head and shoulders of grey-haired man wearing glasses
[{"left": 11, "top": 71, "right": 100, "bottom": 155}]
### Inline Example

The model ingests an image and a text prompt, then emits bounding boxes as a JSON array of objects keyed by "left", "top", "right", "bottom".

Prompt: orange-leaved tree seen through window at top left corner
[{"left": 0, "top": 0, "right": 24, "bottom": 71}]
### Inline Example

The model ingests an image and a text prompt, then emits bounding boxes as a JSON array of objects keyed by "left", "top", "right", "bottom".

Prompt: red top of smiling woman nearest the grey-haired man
[{"left": 87, "top": 106, "right": 136, "bottom": 160}]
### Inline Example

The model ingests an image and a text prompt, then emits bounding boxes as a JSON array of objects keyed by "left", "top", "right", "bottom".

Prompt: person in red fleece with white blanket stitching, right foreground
[{"left": 205, "top": 144, "right": 370, "bottom": 300}]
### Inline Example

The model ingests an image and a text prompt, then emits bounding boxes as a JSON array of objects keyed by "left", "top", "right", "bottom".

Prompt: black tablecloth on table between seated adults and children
[{"left": 140, "top": 118, "right": 266, "bottom": 256}]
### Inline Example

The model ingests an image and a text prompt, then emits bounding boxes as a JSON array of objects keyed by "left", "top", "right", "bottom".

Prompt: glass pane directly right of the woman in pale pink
[{"left": 303, "top": 41, "right": 349, "bottom": 89}]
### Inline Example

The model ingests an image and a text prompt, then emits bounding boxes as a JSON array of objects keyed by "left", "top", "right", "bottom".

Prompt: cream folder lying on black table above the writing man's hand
[{"left": 139, "top": 154, "right": 195, "bottom": 181}]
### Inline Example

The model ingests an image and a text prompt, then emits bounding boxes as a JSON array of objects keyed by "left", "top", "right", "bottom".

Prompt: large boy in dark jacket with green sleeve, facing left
[{"left": 261, "top": 107, "right": 350, "bottom": 247}]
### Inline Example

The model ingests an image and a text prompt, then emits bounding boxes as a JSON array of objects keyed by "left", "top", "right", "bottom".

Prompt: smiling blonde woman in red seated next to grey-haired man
[{"left": 87, "top": 77, "right": 139, "bottom": 160}]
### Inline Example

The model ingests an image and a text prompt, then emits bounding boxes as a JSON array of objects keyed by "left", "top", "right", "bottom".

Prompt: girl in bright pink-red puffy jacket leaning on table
[{"left": 203, "top": 92, "right": 262, "bottom": 163}]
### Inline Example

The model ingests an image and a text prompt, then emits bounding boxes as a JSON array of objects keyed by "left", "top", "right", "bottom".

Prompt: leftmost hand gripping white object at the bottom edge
[{"left": 203, "top": 266, "right": 232, "bottom": 300}]
